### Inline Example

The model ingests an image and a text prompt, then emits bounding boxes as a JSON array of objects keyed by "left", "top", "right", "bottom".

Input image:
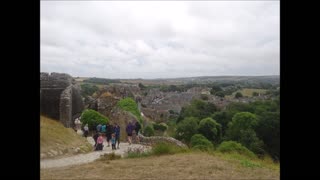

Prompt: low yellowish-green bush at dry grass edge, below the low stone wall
[{"left": 152, "top": 142, "right": 187, "bottom": 155}]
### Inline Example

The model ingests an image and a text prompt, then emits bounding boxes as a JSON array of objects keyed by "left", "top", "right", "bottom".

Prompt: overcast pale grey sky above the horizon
[{"left": 40, "top": 1, "right": 280, "bottom": 79}]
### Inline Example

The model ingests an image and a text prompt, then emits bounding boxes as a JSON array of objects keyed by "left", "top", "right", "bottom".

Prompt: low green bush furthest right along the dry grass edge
[{"left": 217, "top": 141, "right": 256, "bottom": 157}]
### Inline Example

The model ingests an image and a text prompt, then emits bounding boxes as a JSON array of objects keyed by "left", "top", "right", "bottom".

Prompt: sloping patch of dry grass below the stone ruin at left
[{"left": 40, "top": 116, "right": 92, "bottom": 158}]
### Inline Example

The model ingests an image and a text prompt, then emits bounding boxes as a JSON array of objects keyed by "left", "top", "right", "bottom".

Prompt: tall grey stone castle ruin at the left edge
[{"left": 40, "top": 72, "right": 84, "bottom": 128}]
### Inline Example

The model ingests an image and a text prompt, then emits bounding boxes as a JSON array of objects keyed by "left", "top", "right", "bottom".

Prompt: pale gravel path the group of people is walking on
[{"left": 40, "top": 137, "right": 148, "bottom": 168}]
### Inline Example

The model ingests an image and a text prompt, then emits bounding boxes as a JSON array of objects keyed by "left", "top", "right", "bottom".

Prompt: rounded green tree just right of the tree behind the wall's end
[{"left": 198, "top": 118, "right": 221, "bottom": 143}]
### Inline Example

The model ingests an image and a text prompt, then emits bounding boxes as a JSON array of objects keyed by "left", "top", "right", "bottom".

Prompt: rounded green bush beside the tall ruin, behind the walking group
[{"left": 81, "top": 109, "right": 109, "bottom": 129}]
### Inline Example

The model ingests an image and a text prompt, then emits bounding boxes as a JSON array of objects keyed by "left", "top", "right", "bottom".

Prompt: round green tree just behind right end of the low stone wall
[{"left": 175, "top": 117, "right": 199, "bottom": 143}]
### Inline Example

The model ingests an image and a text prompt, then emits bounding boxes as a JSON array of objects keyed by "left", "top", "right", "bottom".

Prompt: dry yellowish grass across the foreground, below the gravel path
[{"left": 40, "top": 152, "right": 279, "bottom": 180}]
